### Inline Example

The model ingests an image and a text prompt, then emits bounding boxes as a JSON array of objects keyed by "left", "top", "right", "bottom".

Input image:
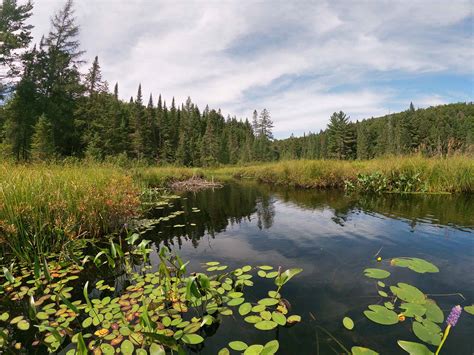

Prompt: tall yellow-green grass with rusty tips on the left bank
[{"left": 0, "top": 164, "right": 140, "bottom": 262}]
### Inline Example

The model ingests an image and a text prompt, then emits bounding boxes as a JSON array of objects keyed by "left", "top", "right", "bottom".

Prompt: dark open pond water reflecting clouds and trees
[{"left": 146, "top": 183, "right": 474, "bottom": 355}]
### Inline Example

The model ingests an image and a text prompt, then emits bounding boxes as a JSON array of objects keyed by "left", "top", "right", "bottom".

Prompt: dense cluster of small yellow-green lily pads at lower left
[{"left": 0, "top": 227, "right": 302, "bottom": 354}]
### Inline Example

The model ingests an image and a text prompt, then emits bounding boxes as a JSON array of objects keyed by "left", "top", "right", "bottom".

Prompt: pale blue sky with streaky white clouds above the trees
[{"left": 31, "top": 0, "right": 474, "bottom": 138}]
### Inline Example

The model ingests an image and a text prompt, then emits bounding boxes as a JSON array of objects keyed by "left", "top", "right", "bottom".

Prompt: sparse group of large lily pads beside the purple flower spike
[{"left": 336, "top": 257, "right": 474, "bottom": 355}]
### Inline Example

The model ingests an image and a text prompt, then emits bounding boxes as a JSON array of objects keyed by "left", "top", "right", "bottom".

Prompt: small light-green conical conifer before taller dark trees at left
[{"left": 31, "top": 115, "right": 56, "bottom": 161}]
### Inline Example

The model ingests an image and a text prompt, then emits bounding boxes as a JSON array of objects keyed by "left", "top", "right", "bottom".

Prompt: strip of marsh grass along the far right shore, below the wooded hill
[{"left": 211, "top": 157, "right": 474, "bottom": 192}]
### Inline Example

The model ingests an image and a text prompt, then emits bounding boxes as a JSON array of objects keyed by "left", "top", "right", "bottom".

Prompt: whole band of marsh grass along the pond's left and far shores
[{"left": 0, "top": 157, "right": 474, "bottom": 261}]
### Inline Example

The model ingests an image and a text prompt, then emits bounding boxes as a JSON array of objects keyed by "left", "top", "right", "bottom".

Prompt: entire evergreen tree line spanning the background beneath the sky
[{"left": 0, "top": 0, "right": 474, "bottom": 166}]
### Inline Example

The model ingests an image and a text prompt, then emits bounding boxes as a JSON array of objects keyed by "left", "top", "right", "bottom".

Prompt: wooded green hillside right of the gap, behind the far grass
[{"left": 274, "top": 103, "right": 474, "bottom": 159}]
